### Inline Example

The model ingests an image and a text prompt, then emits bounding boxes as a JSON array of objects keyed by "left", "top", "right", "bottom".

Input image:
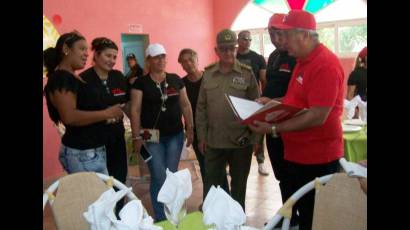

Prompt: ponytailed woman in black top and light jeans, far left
[{"left": 43, "top": 32, "right": 123, "bottom": 174}]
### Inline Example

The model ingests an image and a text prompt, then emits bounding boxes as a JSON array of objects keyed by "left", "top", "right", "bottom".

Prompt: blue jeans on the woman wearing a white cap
[{"left": 146, "top": 132, "right": 184, "bottom": 222}]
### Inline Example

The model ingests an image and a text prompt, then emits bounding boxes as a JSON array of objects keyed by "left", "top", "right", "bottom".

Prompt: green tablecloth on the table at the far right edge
[{"left": 343, "top": 127, "right": 367, "bottom": 162}]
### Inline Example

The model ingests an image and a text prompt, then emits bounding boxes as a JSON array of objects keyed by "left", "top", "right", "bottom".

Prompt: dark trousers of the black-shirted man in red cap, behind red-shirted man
[{"left": 266, "top": 135, "right": 298, "bottom": 226}]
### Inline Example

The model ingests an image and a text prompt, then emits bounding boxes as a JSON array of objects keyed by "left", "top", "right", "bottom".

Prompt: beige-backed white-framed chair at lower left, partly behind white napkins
[{"left": 43, "top": 172, "right": 148, "bottom": 230}]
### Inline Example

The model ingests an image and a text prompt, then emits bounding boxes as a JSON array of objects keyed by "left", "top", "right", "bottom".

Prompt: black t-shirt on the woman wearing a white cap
[{"left": 131, "top": 73, "right": 185, "bottom": 136}]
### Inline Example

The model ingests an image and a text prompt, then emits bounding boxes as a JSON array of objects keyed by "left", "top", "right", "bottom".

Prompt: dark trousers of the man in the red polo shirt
[{"left": 286, "top": 160, "right": 339, "bottom": 230}]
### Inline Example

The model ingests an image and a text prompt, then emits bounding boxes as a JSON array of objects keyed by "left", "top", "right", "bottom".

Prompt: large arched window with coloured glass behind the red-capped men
[{"left": 232, "top": 0, "right": 367, "bottom": 58}]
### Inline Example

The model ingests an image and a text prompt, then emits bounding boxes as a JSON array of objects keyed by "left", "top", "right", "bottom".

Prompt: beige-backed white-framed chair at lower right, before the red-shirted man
[{"left": 264, "top": 158, "right": 367, "bottom": 230}]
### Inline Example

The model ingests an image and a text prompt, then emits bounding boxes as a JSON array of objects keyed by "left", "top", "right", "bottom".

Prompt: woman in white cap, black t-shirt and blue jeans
[{"left": 130, "top": 44, "right": 193, "bottom": 221}]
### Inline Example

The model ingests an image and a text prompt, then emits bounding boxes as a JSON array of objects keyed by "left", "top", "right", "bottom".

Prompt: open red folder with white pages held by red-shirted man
[{"left": 225, "top": 94, "right": 305, "bottom": 125}]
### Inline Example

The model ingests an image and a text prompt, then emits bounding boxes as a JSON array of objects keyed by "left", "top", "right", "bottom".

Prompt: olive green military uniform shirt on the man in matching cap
[{"left": 195, "top": 60, "right": 262, "bottom": 148}]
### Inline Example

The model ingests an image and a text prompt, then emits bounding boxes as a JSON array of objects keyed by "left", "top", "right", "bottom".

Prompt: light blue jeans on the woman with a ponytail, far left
[{"left": 60, "top": 144, "right": 108, "bottom": 175}]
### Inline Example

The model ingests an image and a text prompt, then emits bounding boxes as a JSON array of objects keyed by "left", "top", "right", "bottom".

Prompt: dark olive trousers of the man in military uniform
[{"left": 204, "top": 146, "right": 252, "bottom": 210}]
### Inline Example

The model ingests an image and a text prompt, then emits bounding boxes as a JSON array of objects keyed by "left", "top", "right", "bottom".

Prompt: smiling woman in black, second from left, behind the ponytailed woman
[{"left": 80, "top": 37, "right": 129, "bottom": 190}]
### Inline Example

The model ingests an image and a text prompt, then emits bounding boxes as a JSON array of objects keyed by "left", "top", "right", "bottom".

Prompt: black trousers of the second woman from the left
[{"left": 105, "top": 135, "right": 128, "bottom": 214}]
